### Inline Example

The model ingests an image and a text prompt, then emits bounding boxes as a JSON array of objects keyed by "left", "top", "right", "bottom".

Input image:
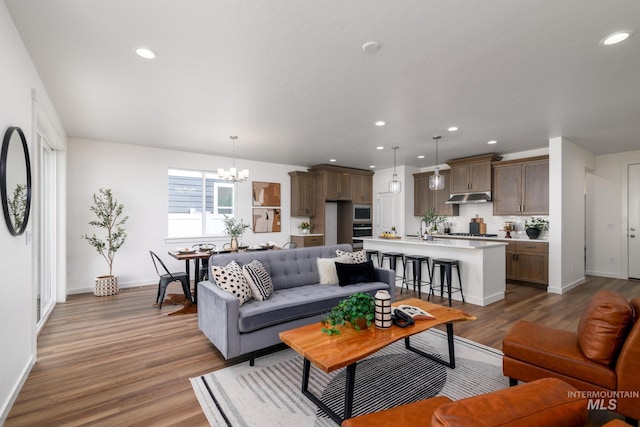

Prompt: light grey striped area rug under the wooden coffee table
[{"left": 191, "top": 329, "right": 509, "bottom": 427}]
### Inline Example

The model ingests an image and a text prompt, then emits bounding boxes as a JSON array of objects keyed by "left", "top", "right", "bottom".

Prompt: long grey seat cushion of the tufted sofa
[{"left": 238, "top": 282, "right": 389, "bottom": 333}]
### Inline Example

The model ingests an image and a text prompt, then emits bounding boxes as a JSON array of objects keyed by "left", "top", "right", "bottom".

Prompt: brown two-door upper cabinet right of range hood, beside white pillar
[{"left": 493, "top": 156, "right": 549, "bottom": 215}]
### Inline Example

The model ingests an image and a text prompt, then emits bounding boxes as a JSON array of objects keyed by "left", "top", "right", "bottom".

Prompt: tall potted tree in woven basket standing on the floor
[{"left": 82, "top": 188, "right": 129, "bottom": 296}]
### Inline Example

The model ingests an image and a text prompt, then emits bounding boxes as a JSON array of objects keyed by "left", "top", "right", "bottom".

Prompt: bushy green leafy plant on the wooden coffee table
[{"left": 322, "top": 292, "right": 376, "bottom": 335}]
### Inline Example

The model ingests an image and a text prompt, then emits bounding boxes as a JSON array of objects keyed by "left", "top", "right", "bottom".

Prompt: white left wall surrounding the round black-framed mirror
[{"left": 0, "top": 2, "right": 64, "bottom": 424}]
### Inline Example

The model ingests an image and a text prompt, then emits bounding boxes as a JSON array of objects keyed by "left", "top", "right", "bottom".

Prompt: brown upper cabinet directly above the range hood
[{"left": 447, "top": 153, "right": 502, "bottom": 193}]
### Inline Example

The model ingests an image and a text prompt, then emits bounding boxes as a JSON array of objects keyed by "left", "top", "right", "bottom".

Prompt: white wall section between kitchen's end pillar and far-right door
[{"left": 586, "top": 150, "right": 640, "bottom": 279}]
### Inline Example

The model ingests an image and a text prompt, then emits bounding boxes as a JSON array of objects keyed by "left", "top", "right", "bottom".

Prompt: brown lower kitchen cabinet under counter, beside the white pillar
[{"left": 505, "top": 241, "right": 549, "bottom": 285}]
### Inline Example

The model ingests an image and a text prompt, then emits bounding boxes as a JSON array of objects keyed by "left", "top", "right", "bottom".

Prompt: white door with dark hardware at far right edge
[{"left": 627, "top": 163, "right": 640, "bottom": 279}]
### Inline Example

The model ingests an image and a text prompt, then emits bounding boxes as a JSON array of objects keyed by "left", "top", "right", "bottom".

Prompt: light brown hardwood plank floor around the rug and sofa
[{"left": 5, "top": 277, "right": 640, "bottom": 427}]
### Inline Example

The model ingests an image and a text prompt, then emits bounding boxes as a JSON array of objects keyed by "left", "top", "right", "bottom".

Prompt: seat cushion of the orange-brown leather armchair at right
[{"left": 502, "top": 320, "right": 616, "bottom": 390}]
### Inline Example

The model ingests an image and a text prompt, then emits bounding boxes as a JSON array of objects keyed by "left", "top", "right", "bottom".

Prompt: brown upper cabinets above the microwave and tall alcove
[{"left": 309, "top": 165, "right": 373, "bottom": 204}]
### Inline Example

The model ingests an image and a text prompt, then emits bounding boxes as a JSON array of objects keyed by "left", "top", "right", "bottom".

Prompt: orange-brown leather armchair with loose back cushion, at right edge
[{"left": 502, "top": 291, "right": 640, "bottom": 422}]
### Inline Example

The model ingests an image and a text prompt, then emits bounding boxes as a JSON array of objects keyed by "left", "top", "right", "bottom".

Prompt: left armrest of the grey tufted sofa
[{"left": 196, "top": 281, "right": 240, "bottom": 359}]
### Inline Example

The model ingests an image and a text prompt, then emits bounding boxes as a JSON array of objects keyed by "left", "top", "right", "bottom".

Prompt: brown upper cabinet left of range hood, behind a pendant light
[{"left": 413, "top": 169, "right": 459, "bottom": 216}]
